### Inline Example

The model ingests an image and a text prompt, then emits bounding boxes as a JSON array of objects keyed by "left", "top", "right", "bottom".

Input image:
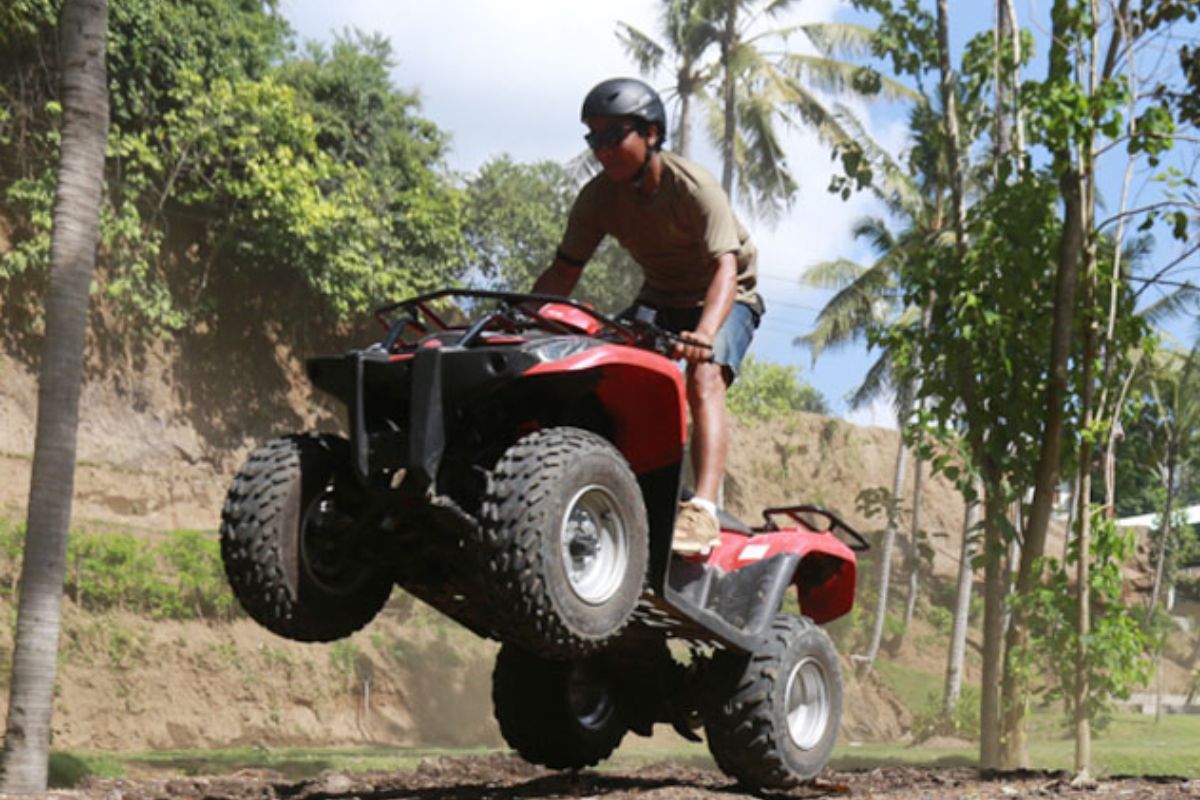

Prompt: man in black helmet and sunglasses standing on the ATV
[{"left": 533, "top": 78, "right": 762, "bottom": 555}]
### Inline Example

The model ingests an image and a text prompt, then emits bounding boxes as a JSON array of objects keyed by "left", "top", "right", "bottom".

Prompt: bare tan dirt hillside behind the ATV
[{"left": 0, "top": 336, "right": 1190, "bottom": 751}]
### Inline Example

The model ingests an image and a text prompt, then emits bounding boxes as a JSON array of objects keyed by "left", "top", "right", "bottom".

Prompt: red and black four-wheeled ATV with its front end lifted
[{"left": 221, "top": 290, "right": 866, "bottom": 788}]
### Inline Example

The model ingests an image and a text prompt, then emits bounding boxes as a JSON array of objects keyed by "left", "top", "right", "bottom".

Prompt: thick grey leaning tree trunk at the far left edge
[{"left": 0, "top": 0, "right": 108, "bottom": 794}]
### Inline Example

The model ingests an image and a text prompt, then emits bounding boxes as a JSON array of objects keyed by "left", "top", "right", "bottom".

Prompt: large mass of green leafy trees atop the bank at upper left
[{"left": 0, "top": 0, "right": 466, "bottom": 332}]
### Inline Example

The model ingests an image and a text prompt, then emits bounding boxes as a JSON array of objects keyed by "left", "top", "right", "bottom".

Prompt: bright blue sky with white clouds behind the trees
[{"left": 280, "top": 0, "right": 1190, "bottom": 427}]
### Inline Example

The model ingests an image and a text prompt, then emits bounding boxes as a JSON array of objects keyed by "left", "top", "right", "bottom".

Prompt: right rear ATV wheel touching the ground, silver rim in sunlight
[{"left": 702, "top": 614, "right": 842, "bottom": 789}]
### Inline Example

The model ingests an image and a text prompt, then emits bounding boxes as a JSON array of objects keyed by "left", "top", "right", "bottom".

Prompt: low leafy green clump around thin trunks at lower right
[{"left": 1009, "top": 512, "right": 1151, "bottom": 718}]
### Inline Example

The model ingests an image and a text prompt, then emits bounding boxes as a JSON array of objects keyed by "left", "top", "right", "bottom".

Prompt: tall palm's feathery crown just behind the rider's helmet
[{"left": 618, "top": 0, "right": 917, "bottom": 218}]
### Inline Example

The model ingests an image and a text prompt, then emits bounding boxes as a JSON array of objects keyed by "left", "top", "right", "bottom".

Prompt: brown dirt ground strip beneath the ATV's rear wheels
[{"left": 42, "top": 756, "right": 1200, "bottom": 800}]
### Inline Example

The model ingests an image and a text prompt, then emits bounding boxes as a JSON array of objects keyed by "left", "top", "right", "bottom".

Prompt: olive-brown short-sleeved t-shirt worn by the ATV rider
[{"left": 558, "top": 152, "right": 757, "bottom": 308}]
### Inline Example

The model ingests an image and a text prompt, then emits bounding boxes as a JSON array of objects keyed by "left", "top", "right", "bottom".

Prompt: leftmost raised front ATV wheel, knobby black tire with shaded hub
[{"left": 221, "top": 434, "right": 391, "bottom": 642}]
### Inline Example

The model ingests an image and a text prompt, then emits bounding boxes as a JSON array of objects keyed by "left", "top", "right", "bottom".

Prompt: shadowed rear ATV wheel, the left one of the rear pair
[{"left": 492, "top": 644, "right": 626, "bottom": 770}]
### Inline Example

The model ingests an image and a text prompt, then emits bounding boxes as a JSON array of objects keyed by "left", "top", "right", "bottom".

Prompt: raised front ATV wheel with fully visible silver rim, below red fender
[{"left": 479, "top": 427, "right": 649, "bottom": 658}]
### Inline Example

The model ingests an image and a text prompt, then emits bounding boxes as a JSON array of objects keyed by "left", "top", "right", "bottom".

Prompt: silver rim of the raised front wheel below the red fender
[{"left": 559, "top": 483, "right": 629, "bottom": 606}]
